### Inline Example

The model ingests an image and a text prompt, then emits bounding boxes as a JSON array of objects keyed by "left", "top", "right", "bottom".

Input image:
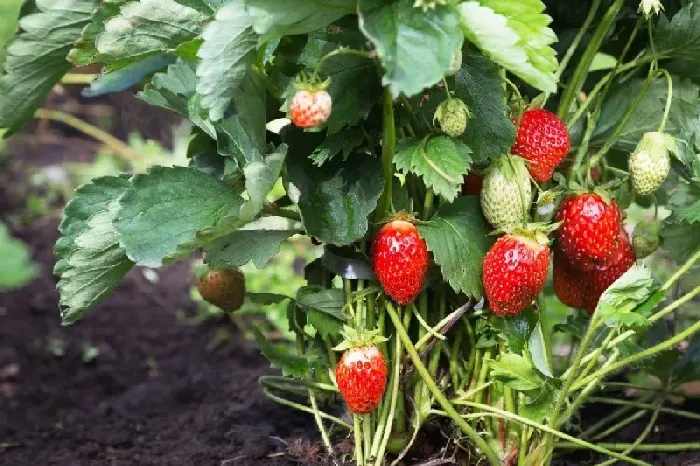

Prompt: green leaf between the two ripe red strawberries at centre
[{"left": 418, "top": 196, "right": 492, "bottom": 299}]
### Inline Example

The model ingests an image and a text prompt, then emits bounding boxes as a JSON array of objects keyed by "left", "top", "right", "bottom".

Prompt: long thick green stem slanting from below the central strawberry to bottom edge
[{"left": 386, "top": 302, "right": 501, "bottom": 466}]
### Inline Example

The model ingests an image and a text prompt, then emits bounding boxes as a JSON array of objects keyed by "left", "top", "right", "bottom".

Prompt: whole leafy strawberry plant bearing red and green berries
[{"left": 0, "top": 0, "right": 700, "bottom": 466}]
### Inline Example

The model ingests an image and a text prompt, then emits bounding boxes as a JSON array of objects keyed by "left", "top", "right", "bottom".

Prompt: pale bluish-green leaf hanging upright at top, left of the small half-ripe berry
[{"left": 197, "top": 0, "right": 257, "bottom": 121}]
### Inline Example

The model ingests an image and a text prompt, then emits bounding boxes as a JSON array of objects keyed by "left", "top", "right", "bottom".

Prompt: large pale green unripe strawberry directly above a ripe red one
[{"left": 481, "top": 155, "right": 532, "bottom": 230}]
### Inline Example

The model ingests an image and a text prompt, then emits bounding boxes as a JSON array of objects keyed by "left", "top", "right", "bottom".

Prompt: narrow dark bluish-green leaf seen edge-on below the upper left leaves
[{"left": 81, "top": 55, "right": 175, "bottom": 97}]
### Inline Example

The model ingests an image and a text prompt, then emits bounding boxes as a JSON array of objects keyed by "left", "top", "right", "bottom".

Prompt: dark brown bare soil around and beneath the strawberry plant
[{"left": 0, "top": 94, "right": 700, "bottom": 466}]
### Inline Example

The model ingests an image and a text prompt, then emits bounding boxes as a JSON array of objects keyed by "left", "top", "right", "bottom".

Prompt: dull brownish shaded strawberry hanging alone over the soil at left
[{"left": 196, "top": 267, "right": 245, "bottom": 312}]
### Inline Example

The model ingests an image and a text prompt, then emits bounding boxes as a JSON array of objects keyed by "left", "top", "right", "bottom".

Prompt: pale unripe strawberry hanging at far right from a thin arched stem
[{"left": 629, "top": 132, "right": 675, "bottom": 196}]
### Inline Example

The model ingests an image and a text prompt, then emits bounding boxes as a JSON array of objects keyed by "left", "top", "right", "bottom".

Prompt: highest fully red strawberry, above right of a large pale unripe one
[{"left": 510, "top": 109, "right": 571, "bottom": 183}]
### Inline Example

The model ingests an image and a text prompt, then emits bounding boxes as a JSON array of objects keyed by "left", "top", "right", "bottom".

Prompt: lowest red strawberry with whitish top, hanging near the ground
[{"left": 335, "top": 345, "right": 387, "bottom": 414}]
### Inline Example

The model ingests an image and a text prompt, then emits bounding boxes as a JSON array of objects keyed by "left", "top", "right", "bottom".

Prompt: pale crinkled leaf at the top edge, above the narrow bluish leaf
[{"left": 95, "top": 0, "right": 207, "bottom": 63}]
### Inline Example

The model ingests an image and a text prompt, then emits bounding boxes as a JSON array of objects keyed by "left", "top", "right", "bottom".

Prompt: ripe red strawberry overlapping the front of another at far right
[{"left": 556, "top": 193, "right": 622, "bottom": 270}]
